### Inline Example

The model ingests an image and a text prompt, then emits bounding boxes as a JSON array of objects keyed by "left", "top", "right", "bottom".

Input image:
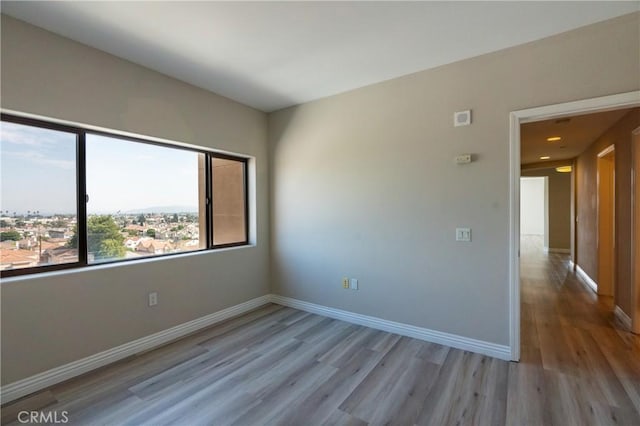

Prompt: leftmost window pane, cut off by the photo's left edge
[{"left": 0, "top": 121, "right": 78, "bottom": 270}]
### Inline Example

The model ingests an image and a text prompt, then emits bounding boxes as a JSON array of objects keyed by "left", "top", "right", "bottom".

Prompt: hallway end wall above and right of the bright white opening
[{"left": 522, "top": 169, "right": 571, "bottom": 250}]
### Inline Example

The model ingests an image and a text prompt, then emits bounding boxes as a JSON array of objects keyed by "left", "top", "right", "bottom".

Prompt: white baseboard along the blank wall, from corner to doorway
[{"left": 271, "top": 295, "right": 511, "bottom": 361}]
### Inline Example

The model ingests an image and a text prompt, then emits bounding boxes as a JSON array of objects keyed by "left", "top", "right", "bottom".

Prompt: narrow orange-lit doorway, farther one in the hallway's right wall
[{"left": 597, "top": 145, "right": 616, "bottom": 297}]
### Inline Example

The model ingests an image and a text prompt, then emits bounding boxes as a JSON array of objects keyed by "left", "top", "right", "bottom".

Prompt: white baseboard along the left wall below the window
[{"left": 1, "top": 295, "right": 271, "bottom": 404}]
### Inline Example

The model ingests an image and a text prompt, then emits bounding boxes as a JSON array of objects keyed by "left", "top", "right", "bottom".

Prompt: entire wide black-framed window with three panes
[{"left": 0, "top": 114, "right": 248, "bottom": 277}]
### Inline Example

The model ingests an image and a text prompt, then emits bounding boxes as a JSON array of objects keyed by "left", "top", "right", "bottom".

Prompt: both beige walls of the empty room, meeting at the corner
[{"left": 0, "top": 10, "right": 640, "bottom": 383}]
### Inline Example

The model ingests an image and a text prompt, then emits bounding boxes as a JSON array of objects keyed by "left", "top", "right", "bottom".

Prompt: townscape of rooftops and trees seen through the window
[{"left": 0, "top": 211, "right": 202, "bottom": 270}]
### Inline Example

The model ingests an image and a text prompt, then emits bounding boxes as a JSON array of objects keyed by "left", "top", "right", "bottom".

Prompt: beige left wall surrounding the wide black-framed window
[{"left": 0, "top": 16, "right": 269, "bottom": 383}]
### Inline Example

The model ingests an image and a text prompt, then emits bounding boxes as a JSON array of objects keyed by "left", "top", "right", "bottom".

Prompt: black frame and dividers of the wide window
[{"left": 0, "top": 112, "right": 250, "bottom": 278}]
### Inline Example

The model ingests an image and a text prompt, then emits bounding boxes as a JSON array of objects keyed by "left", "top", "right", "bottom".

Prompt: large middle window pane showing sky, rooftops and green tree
[{"left": 86, "top": 134, "right": 206, "bottom": 263}]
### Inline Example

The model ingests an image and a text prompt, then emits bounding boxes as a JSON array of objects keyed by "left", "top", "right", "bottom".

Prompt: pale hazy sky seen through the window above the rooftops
[{"left": 0, "top": 122, "right": 199, "bottom": 216}]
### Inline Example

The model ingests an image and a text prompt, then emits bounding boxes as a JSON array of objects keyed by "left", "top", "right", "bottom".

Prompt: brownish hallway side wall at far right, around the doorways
[{"left": 576, "top": 108, "right": 640, "bottom": 314}]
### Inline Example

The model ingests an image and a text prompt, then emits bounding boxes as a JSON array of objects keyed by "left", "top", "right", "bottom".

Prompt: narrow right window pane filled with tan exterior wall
[{"left": 212, "top": 158, "right": 247, "bottom": 245}]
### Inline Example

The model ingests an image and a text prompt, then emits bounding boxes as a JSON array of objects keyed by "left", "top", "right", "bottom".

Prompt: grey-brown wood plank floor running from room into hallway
[{"left": 2, "top": 241, "right": 640, "bottom": 426}]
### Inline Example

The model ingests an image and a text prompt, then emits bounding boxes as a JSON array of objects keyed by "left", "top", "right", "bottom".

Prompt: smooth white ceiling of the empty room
[{"left": 1, "top": 1, "right": 640, "bottom": 111}]
